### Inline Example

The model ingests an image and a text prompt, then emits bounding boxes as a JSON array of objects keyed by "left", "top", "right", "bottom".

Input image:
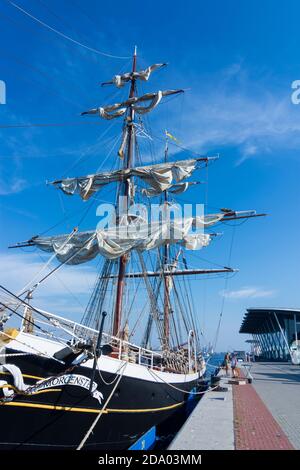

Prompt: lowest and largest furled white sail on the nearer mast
[{"left": 30, "top": 217, "right": 211, "bottom": 265}]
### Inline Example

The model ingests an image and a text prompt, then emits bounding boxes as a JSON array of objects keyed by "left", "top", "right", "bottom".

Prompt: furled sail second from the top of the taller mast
[{"left": 81, "top": 90, "right": 183, "bottom": 119}]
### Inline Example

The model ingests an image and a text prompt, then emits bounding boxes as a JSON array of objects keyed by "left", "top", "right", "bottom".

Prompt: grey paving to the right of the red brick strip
[{"left": 251, "top": 362, "right": 300, "bottom": 450}]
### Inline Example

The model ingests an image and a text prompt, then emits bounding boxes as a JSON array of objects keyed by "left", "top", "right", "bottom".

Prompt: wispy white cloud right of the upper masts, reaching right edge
[{"left": 157, "top": 62, "right": 300, "bottom": 165}]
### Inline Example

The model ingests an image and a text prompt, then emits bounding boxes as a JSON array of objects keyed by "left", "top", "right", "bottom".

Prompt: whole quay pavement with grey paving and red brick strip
[{"left": 169, "top": 362, "right": 300, "bottom": 450}]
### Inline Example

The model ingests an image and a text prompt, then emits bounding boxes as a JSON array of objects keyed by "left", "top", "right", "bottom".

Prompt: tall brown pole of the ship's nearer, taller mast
[{"left": 113, "top": 46, "right": 137, "bottom": 336}]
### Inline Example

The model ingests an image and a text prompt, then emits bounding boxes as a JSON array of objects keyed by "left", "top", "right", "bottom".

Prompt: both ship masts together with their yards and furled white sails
[{"left": 7, "top": 48, "right": 263, "bottom": 353}]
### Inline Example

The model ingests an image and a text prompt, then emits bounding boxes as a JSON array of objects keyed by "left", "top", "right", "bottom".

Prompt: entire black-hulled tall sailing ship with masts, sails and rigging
[{"left": 0, "top": 50, "right": 260, "bottom": 450}]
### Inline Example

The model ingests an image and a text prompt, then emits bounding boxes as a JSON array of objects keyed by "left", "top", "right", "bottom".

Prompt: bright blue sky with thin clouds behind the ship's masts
[{"left": 0, "top": 0, "right": 300, "bottom": 350}]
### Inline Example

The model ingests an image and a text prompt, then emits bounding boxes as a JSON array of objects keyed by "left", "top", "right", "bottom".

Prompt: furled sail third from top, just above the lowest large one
[{"left": 52, "top": 158, "right": 199, "bottom": 200}]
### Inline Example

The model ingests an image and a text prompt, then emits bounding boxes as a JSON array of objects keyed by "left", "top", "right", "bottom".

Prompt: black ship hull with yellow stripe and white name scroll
[{"left": 0, "top": 349, "right": 202, "bottom": 450}]
